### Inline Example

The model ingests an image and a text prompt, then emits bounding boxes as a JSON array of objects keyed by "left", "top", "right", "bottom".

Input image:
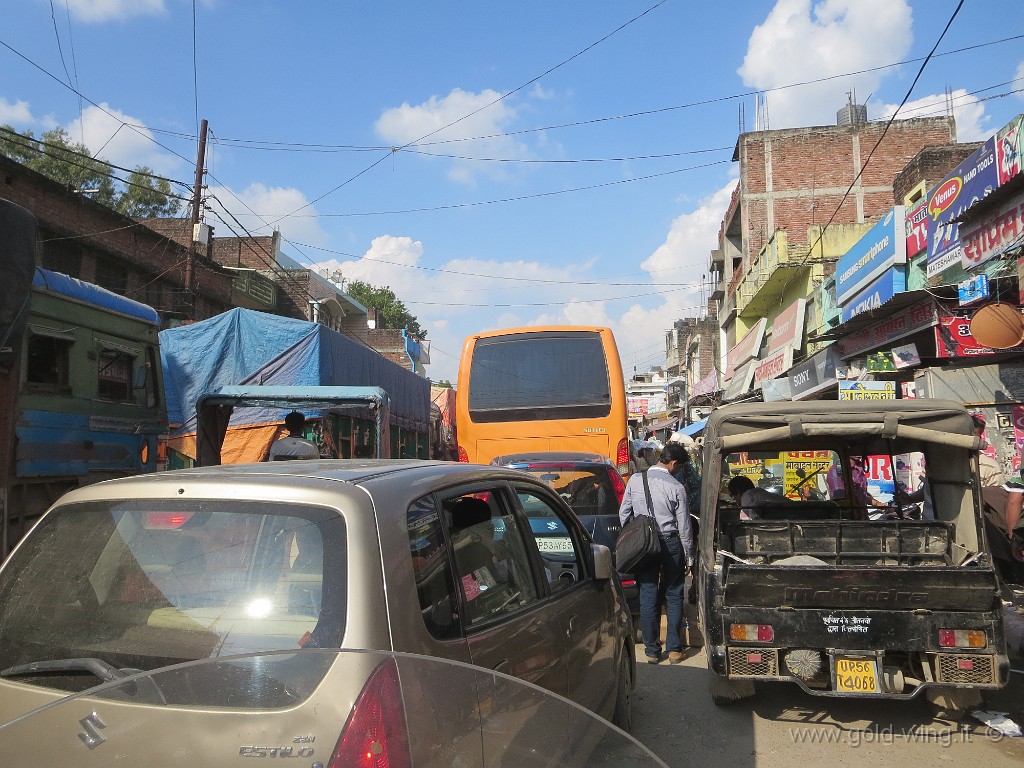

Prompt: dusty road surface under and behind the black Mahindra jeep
[{"left": 633, "top": 614, "right": 1024, "bottom": 768}]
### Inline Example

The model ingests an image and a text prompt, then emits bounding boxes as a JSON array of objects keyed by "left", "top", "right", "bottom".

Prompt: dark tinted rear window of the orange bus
[{"left": 469, "top": 331, "right": 611, "bottom": 423}]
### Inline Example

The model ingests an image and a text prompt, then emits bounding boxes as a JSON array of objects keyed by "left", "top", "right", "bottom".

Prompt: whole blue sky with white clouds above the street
[{"left": 0, "top": 0, "right": 1024, "bottom": 382}]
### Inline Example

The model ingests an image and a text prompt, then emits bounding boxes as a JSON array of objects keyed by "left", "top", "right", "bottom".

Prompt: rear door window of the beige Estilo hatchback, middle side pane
[{"left": 443, "top": 492, "right": 540, "bottom": 628}]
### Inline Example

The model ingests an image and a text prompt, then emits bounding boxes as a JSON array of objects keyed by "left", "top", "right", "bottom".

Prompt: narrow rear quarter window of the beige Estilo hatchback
[{"left": 407, "top": 496, "right": 460, "bottom": 640}]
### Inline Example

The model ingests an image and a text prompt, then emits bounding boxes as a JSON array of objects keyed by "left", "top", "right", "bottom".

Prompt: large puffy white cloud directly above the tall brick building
[{"left": 738, "top": 0, "right": 912, "bottom": 128}]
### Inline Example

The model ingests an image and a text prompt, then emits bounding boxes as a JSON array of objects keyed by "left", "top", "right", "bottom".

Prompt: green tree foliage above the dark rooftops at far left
[{"left": 0, "top": 125, "right": 181, "bottom": 218}]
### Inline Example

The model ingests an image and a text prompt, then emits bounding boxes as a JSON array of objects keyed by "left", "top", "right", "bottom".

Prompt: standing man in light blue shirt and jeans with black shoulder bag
[{"left": 618, "top": 442, "right": 693, "bottom": 664}]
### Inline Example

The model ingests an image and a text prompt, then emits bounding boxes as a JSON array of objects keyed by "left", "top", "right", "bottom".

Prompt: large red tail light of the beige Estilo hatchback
[{"left": 328, "top": 658, "right": 413, "bottom": 768}]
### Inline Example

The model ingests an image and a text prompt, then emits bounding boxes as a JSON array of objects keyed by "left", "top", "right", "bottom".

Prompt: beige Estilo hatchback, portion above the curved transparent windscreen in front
[{"left": 0, "top": 461, "right": 634, "bottom": 730}]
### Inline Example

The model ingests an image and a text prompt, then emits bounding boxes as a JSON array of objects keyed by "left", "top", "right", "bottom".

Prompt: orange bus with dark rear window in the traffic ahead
[{"left": 456, "top": 326, "right": 629, "bottom": 475}]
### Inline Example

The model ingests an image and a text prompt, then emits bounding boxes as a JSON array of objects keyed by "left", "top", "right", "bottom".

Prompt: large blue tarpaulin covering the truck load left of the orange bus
[{"left": 160, "top": 308, "right": 430, "bottom": 437}]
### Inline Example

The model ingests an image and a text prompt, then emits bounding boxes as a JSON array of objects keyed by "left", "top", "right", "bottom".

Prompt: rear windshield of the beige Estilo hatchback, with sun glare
[{"left": 0, "top": 500, "right": 346, "bottom": 688}]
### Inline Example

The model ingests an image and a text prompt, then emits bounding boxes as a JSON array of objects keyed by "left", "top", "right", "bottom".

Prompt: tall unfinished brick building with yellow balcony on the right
[{"left": 710, "top": 112, "right": 956, "bottom": 399}]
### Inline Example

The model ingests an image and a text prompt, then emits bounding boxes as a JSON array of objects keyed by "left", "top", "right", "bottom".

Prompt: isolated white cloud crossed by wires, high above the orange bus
[{"left": 375, "top": 88, "right": 529, "bottom": 184}]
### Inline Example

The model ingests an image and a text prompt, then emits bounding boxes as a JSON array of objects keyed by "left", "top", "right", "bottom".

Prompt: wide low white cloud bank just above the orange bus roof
[{"left": 307, "top": 181, "right": 735, "bottom": 382}]
